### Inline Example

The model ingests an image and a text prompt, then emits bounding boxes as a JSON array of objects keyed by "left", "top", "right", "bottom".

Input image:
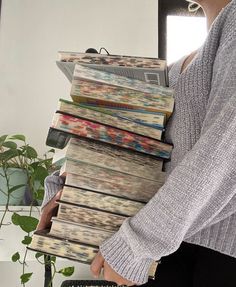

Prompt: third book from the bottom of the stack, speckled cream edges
[{"left": 57, "top": 202, "right": 127, "bottom": 232}]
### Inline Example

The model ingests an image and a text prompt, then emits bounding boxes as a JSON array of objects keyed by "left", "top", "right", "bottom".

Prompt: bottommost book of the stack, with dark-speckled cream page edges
[{"left": 28, "top": 230, "right": 99, "bottom": 264}]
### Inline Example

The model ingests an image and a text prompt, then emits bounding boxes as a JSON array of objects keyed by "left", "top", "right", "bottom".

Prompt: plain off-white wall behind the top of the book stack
[{"left": 0, "top": 0, "right": 158, "bottom": 156}]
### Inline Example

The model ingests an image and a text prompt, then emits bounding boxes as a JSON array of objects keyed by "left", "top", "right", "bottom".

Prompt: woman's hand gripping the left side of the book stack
[{"left": 36, "top": 190, "right": 62, "bottom": 230}]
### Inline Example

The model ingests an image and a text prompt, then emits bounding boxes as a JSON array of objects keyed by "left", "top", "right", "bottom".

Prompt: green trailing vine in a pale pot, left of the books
[{"left": 0, "top": 135, "right": 74, "bottom": 286}]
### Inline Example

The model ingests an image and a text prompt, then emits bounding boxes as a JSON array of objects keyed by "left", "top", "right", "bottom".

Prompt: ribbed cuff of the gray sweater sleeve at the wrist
[{"left": 100, "top": 232, "right": 153, "bottom": 284}]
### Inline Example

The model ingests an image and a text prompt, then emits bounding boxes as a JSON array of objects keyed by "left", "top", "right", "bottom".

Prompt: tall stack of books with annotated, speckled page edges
[{"left": 30, "top": 52, "right": 174, "bottom": 276}]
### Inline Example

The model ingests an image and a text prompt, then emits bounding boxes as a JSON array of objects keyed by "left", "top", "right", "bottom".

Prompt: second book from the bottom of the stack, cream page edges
[{"left": 49, "top": 217, "right": 113, "bottom": 246}]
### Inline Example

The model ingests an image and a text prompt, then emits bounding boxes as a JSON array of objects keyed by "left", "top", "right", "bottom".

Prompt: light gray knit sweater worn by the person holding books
[{"left": 42, "top": 0, "right": 236, "bottom": 284}]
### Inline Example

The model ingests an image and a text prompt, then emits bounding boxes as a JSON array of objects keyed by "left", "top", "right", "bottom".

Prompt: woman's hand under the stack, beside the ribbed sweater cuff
[{"left": 90, "top": 252, "right": 135, "bottom": 286}]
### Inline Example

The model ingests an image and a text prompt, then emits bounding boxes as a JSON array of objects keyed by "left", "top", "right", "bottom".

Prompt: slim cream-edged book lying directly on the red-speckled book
[{"left": 57, "top": 99, "right": 162, "bottom": 140}]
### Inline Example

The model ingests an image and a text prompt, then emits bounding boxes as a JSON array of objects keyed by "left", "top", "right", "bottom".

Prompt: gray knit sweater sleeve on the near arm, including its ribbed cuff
[{"left": 100, "top": 43, "right": 236, "bottom": 284}]
